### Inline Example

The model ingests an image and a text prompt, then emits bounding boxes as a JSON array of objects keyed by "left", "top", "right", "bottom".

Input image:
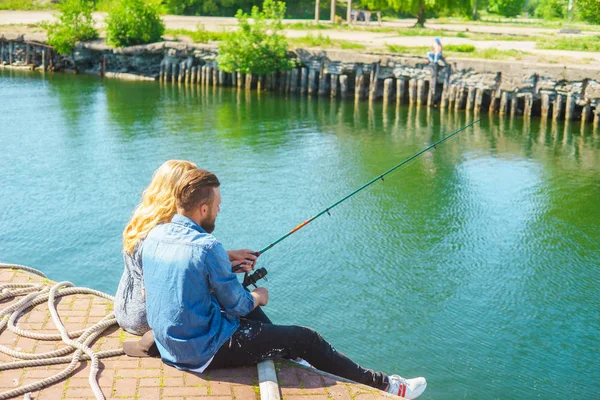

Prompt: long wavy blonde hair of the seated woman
[{"left": 123, "top": 160, "right": 198, "bottom": 254}]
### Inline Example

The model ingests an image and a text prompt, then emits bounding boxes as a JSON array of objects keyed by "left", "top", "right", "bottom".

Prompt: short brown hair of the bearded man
[{"left": 175, "top": 168, "right": 221, "bottom": 212}]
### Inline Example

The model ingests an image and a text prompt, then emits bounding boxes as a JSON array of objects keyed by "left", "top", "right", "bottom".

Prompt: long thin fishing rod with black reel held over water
[{"left": 244, "top": 119, "right": 481, "bottom": 287}]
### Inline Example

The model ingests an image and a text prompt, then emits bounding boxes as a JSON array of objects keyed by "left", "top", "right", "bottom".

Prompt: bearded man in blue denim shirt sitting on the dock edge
[{"left": 142, "top": 169, "right": 427, "bottom": 399}]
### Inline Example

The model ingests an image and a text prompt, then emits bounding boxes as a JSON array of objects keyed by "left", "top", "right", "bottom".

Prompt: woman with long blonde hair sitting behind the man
[{"left": 115, "top": 160, "right": 262, "bottom": 335}]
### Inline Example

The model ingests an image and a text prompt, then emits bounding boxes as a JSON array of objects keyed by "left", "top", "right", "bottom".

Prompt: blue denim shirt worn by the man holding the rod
[{"left": 142, "top": 214, "right": 254, "bottom": 369}]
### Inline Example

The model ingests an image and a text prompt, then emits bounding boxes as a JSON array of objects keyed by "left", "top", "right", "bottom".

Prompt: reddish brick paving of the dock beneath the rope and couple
[{"left": 0, "top": 269, "right": 398, "bottom": 400}]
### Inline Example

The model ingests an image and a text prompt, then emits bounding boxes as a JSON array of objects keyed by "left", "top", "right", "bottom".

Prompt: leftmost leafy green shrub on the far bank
[{"left": 44, "top": 0, "right": 98, "bottom": 54}]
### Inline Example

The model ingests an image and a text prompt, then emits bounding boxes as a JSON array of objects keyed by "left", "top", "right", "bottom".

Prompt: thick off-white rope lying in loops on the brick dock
[{"left": 0, "top": 263, "right": 125, "bottom": 400}]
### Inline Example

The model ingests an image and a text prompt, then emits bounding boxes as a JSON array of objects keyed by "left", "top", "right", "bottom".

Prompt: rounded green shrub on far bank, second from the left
[{"left": 106, "top": 0, "right": 165, "bottom": 47}]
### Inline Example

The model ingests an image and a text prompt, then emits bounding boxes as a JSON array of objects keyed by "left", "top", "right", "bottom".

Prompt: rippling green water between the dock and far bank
[{"left": 0, "top": 71, "right": 600, "bottom": 399}]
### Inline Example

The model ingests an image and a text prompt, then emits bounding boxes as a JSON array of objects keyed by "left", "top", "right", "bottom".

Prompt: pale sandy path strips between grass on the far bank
[{"left": 0, "top": 11, "right": 600, "bottom": 64}]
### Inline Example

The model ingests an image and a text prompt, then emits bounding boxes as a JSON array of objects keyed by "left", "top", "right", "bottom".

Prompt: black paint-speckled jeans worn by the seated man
[{"left": 208, "top": 318, "right": 388, "bottom": 390}]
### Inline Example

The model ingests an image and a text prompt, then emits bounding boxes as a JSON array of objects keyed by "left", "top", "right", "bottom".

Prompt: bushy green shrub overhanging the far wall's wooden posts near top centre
[{"left": 217, "top": 0, "right": 294, "bottom": 75}]
